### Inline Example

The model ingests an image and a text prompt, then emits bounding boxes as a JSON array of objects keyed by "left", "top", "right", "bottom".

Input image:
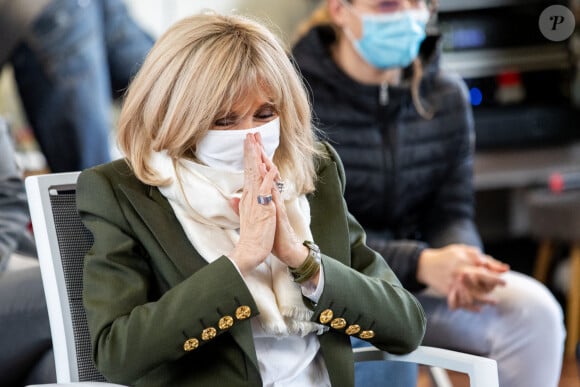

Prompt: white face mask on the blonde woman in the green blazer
[{"left": 195, "top": 118, "right": 280, "bottom": 172}]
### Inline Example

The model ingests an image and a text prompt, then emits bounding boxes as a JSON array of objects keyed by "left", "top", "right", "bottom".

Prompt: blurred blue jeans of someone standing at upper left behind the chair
[{"left": 11, "top": 0, "right": 154, "bottom": 172}]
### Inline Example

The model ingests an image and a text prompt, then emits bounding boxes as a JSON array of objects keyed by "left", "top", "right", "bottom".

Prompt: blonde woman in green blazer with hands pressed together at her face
[{"left": 77, "top": 14, "right": 425, "bottom": 386}]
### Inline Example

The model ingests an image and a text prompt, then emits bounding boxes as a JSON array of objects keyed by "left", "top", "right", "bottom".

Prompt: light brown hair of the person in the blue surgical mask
[{"left": 295, "top": 0, "right": 439, "bottom": 120}]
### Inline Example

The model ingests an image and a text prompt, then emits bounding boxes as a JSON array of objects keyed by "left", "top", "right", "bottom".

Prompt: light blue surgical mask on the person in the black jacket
[{"left": 344, "top": 3, "right": 429, "bottom": 69}]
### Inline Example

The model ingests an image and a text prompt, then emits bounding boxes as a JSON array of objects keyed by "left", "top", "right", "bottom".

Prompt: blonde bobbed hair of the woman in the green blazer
[{"left": 118, "top": 13, "right": 318, "bottom": 193}]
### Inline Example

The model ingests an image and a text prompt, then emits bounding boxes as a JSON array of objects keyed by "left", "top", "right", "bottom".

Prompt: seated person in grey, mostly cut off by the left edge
[{"left": 0, "top": 118, "right": 56, "bottom": 387}]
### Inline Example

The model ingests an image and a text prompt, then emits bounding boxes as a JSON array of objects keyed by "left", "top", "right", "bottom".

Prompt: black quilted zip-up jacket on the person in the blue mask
[{"left": 293, "top": 27, "right": 481, "bottom": 290}]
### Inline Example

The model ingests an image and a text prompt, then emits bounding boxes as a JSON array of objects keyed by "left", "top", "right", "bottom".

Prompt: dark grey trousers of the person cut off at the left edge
[{"left": 0, "top": 267, "right": 56, "bottom": 387}]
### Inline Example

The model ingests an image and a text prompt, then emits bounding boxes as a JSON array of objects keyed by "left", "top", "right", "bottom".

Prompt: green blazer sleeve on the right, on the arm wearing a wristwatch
[{"left": 313, "top": 142, "right": 426, "bottom": 353}]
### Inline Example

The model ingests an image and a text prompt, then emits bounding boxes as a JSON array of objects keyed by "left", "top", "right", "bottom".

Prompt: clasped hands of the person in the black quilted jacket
[{"left": 417, "top": 244, "right": 509, "bottom": 311}]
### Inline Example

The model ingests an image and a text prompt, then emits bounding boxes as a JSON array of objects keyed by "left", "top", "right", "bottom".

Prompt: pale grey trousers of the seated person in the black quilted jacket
[{"left": 417, "top": 271, "right": 566, "bottom": 387}]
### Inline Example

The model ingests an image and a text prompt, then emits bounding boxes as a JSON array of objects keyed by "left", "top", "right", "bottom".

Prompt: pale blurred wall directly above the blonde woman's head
[{"left": 126, "top": 0, "right": 320, "bottom": 46}]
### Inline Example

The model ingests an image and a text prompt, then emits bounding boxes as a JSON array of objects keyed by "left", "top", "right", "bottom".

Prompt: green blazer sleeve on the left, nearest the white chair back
[{"left": 77, "top": 169, "right": 258, "bottom": 384}]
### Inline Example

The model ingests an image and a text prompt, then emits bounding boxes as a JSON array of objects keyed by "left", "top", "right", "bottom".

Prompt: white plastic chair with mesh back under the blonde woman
[{"left": 26, "top": 172, "right": 498, "bottom": 387}]
